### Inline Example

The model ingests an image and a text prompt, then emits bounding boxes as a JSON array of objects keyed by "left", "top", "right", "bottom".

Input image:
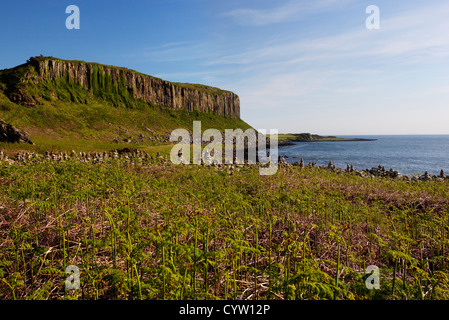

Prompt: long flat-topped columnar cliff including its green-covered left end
[{"left": 3, "top": 57, "right": 240, "bottom": 118}]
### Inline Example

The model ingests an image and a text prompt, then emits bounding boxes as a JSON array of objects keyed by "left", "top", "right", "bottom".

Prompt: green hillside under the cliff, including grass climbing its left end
[{"left": 0, "top": 57, "right": 250, "bottom": 151}]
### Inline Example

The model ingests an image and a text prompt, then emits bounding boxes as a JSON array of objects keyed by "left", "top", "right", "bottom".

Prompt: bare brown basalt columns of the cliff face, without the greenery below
[{"left": 30, "top": 58, "right": 240, "bottom": 118}]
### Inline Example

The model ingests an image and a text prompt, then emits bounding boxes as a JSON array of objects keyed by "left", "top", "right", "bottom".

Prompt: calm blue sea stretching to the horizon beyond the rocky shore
[{"left": 278, "top": 135, "right": 449, "bottom": 176}]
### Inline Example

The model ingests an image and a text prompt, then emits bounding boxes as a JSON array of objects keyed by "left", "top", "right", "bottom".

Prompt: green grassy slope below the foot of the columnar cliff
[{"left": 0, "top": 89, "right": 251, "bottom": 155}]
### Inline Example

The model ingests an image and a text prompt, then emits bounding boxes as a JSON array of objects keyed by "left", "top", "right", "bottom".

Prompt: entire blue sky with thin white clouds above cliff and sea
[{"left": 0, "top": 0, "right": 449, "bottom": 135}]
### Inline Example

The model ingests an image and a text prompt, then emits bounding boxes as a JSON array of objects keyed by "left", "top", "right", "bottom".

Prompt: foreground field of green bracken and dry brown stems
[{"left": 0, "top": 159, "right": 449, "bottom": 299}]
